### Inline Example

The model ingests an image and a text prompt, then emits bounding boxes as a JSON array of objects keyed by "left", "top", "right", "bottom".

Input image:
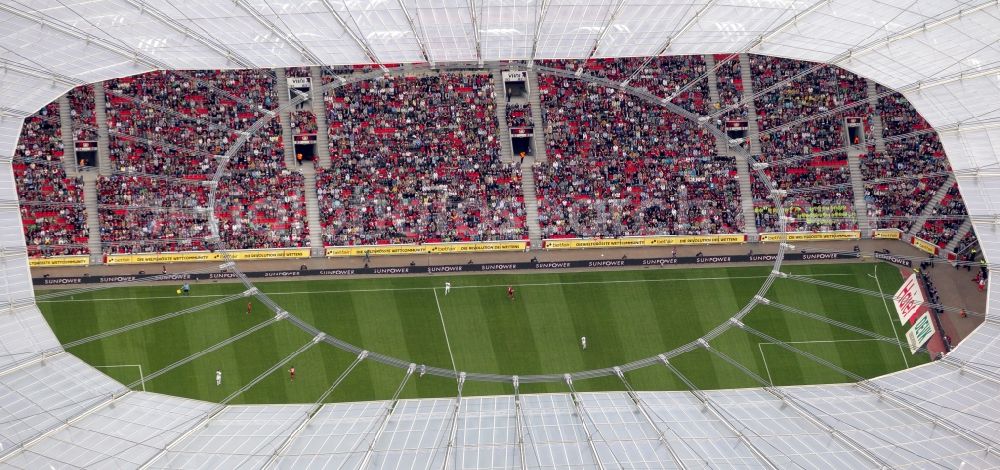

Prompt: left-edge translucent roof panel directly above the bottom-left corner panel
[{"left": 0, "top": 353, "right": 125, "bottom": 449}]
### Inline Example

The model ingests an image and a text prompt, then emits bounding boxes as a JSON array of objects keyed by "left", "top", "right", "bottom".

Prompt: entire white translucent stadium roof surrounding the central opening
[{"left": 0, "top": 0, "right": 1000, "bottom": 468}]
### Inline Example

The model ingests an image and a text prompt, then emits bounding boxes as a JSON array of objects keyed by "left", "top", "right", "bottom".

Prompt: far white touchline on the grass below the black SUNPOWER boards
[{"left": 35, "top": 273, "right": 853, "bottom": 304}]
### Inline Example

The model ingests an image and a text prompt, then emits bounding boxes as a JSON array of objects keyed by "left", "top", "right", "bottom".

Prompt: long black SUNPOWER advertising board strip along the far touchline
[{"left": 32, "top": 252, "right": 858, "bottom": 286}]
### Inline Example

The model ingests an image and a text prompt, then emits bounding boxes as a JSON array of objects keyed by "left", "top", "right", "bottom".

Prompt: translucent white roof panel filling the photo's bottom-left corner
[{"left": 4, "top": 392, "right": 214, "bottom": 469}]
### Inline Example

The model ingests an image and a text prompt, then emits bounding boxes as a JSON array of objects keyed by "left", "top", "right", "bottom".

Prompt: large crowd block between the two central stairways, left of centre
[{"left": 317, "top": 73, "right": 526, "bottom": 245}]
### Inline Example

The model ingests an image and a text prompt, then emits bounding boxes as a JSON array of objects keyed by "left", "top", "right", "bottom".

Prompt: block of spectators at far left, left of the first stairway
[{"left": 12, "top": 102, "right": 89, "bottom": 256}]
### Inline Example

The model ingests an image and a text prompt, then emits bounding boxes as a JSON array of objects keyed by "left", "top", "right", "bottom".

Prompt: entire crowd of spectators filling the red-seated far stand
[{"left": 14, "top": 55, "right": 974, "bottom": 255}]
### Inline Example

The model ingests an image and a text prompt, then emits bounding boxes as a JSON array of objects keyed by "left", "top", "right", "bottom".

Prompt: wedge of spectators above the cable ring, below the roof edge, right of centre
[{"left": 540, "top": 55, "right": 708, "bottom": 114}]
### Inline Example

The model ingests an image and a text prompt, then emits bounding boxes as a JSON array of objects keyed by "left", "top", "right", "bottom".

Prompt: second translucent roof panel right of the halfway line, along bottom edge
[{"left": 521, "top": 394, "right": 597, "bottom": 468}]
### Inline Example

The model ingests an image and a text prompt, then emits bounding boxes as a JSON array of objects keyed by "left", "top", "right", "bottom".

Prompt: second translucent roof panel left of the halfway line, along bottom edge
[{"left": 275, "top": 402, "right": 389, "bottom": 470}]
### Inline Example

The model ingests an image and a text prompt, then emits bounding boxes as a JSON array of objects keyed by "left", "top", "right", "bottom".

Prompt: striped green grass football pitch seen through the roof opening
[{"left": 39, "top": 263, "right": 928, "bottom": 403}]
